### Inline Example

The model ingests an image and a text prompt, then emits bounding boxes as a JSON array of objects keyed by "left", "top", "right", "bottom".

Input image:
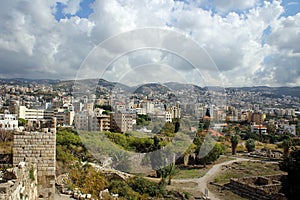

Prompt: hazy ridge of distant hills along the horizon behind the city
[{"left": 0, "top": 78, "right": 300, "bottom": 98}]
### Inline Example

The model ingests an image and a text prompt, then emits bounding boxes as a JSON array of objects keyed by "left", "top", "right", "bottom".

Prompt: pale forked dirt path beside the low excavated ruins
[{"left": 172, "top": 158, "right": 249, "bottom": 200}]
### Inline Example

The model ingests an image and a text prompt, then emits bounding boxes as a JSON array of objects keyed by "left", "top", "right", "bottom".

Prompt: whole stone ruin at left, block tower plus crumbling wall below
[{"left": 0, "top": 118, "right": 56, "bottom": 200}]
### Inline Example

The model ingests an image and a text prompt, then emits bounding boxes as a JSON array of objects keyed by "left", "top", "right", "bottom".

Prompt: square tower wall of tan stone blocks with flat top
[{"left": 13, "top": 128, "right": 56, "bottom": 200}]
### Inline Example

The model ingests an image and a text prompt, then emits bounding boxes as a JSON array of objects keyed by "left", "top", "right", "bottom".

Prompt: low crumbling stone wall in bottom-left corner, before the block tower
[{"left": 0, "top": 162, "right": 38, "bottom": 200}]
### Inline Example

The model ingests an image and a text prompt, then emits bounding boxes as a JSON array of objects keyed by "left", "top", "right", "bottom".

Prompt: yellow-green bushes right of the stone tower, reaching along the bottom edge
[{"left": 57, "top": 129, "right": 171, "bottom": 200}]
